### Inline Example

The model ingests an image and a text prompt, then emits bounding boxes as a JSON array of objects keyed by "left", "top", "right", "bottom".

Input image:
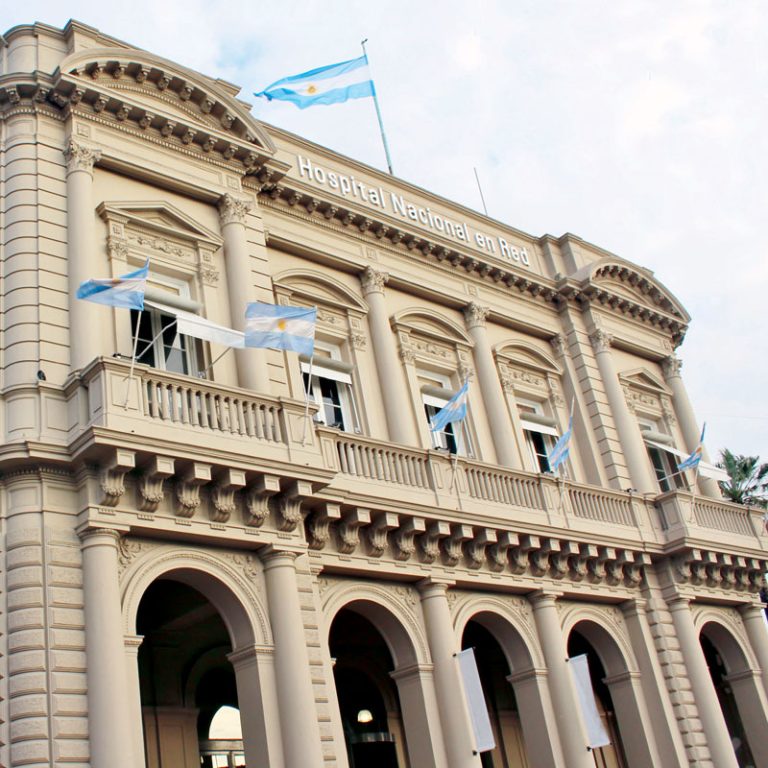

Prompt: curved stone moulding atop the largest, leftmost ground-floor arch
[{"left": 121, "top": 547, "right": 272, "bottom": 650}]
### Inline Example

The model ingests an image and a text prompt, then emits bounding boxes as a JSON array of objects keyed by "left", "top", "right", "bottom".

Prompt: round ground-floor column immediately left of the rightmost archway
[{"left": 668, "top": 596, "right": 738, "bottom": 768}]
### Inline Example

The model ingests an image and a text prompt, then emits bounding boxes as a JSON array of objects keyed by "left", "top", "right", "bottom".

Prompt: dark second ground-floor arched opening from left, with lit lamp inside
[{"left": 329, "top": 608, "right": 408, "bottom": 768}]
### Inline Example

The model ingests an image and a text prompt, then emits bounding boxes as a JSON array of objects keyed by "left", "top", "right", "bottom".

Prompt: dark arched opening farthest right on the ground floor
[{"left": 699, "top": 621, "right": 768, "bottom": 768}]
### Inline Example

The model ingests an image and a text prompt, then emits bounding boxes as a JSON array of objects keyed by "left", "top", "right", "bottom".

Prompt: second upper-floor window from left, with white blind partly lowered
[{"left": 301, "top": 341, "right": 360, "bottom": 432}]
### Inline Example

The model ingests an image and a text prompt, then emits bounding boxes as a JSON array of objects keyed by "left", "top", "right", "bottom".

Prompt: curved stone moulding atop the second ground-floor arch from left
[{"left": 316, "top": 583, "right": 430, "bottom": 669}]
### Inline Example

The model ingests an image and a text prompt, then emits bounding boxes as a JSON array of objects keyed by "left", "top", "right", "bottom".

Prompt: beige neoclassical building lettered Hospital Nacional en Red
[{"left": 0, "top": 22, "right": 768, "bottom": 768}]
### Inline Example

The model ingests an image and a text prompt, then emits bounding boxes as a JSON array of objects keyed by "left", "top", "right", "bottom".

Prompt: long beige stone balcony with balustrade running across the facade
[{"left": 40, "top": 358, "right": 768, "bottom": 557}]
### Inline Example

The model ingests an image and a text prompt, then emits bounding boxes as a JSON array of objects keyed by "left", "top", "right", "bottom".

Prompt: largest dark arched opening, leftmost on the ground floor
[{"left": 136, "top": 578, "right": 245, "bottom": 768}]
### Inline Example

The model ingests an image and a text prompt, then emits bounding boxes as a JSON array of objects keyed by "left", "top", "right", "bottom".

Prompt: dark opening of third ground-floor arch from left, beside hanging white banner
[{"left": 461, "top": 620, "right": 530, "bottom": 768}]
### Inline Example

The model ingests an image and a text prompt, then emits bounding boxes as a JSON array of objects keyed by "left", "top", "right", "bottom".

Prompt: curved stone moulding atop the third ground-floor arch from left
[{"left": 454, "top": 596, "right": 545, "bottom": 673}]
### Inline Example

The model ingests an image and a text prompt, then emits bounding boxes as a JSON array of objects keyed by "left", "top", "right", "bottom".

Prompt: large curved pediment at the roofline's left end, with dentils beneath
[{"left": 54, "top": 46, "right": 276, "bottom": 155}]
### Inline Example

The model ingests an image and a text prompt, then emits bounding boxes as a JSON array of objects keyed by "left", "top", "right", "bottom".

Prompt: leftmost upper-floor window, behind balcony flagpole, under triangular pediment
[{"left": 131, "top": 275, "right": 202, "bottom": 375}]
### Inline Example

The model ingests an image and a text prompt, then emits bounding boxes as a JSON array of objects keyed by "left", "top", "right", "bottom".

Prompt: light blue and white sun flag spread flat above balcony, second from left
[{"left": 245, "top": 301, "right": 317, "bottom": 357}]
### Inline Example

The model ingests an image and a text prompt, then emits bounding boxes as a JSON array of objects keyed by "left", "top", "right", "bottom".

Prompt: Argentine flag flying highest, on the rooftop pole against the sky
[{"left": 254, "top": 54, "right": 374, "bottom": 109}]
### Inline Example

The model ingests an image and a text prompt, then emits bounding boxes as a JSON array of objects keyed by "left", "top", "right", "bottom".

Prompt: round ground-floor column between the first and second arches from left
[{"left": 262, "top": 547, "right": 324, "bottom": 768}]
